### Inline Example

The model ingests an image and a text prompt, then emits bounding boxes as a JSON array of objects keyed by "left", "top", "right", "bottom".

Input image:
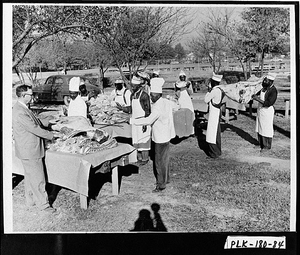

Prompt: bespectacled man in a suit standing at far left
[{"left": 12, "top": 85, "right": 56, "bottom": 213}]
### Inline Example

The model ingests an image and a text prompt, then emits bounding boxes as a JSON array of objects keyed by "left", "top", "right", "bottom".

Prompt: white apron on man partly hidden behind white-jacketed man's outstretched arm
[{"left": 131, "top": 92, "right": 151, "bottom": 151}]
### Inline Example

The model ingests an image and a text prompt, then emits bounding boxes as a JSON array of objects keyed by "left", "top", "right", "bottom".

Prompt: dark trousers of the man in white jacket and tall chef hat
[{"left": 153, "top": 142, "right": 170, "bottom": 189}]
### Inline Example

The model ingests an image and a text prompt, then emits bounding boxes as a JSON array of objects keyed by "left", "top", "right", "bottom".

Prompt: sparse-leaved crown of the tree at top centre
[{"left": 85, "top": 6, "right": 190, "bottom": 85}]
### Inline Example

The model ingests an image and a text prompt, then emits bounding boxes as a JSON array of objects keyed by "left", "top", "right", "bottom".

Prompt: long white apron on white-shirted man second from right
[{"left": 206, "top": 101, "right": 220, "bottom": 144}]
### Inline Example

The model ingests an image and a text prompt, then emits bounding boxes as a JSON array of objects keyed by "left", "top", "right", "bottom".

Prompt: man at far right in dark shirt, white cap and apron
[{"left": 252, "top": 73, "right": 278, "bottom": 153}]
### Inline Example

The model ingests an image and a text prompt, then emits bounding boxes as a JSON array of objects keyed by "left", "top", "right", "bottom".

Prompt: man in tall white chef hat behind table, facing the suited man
[{"left": 68, "top": 77, "right": 87, "bottom": 118}]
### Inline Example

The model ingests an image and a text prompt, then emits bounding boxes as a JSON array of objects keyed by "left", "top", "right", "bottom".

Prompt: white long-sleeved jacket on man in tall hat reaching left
[{"left": 130, "top": 98, "right": 176, "bottom": 143}]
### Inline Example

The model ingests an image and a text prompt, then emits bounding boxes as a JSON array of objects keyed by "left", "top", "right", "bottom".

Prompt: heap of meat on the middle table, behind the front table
[{"left": 89, "top": 94, "right": 128, "bottom": 124}]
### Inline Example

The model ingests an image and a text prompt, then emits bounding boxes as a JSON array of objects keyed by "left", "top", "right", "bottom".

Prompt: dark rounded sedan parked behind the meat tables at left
[{"left": 32, "top": 75, "right": 101, "bottom": 105}]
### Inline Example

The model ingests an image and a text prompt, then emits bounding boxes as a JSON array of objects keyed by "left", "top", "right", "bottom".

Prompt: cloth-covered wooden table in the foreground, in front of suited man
[{"left": 12, "top": 143, "right": 137, "bottom": 209}]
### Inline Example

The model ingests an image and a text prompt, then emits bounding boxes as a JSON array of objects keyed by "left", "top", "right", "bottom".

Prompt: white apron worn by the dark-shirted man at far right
[{"left": 255, "top": 92, "right": 275, "bottom": 138}]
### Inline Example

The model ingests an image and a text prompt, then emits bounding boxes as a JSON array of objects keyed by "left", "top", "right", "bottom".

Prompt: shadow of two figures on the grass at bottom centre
[{"left": 130, "top": 203, "right": 167, "bottom": 232}]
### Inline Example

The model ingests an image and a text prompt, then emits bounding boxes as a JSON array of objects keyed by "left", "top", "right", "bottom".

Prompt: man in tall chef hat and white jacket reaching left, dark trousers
[{"left": 130, "top": 78, "right": 175, "bottom": 192}]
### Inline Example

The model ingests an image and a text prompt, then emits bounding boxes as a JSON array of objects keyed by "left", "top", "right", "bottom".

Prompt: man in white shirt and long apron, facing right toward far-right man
[{"left": 204, "top": 72, "right": 225, "bottom": 158}]
